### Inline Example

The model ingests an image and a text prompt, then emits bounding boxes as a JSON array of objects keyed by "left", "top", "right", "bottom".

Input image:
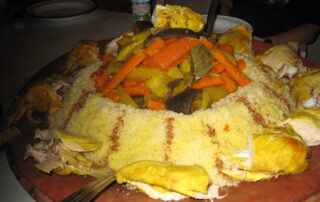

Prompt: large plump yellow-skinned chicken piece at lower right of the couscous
[{"left": 222, "top": 127, "right": 309, "bottom": 181}]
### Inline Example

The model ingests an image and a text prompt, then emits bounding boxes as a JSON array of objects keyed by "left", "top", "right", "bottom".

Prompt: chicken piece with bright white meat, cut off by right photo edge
[{"left": 281, "top": 108, "right": 320, "bottom": 146}]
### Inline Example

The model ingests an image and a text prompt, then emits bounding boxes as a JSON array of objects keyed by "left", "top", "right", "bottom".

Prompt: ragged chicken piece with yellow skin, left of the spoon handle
[{"left": 25, "top": 130, "right": 110, "bottom": 177}]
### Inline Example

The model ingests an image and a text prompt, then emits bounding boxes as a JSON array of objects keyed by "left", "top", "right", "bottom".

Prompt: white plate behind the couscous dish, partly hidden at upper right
[{"left": 203, "top": 15, "right": 252, "bottom": 34}]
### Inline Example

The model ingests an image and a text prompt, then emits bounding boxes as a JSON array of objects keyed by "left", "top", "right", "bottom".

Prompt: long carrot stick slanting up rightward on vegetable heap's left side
[{"left": 103, "top": 52, "right": 147, "bottom": 92}]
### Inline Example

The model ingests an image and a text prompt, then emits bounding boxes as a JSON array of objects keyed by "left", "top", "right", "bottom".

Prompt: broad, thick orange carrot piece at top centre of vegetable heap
[{"left": 144, "top": 37, "right": 199, "bottom": 70}]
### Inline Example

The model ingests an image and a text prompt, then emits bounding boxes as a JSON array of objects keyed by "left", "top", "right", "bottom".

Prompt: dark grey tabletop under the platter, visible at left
[{"left": 0, "top": 9, "right": 133, "bottom": 202}]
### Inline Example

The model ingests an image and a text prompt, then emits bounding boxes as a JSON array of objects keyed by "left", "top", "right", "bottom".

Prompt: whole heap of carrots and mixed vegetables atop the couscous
[{"left": 91, "top": 31, "right": 251, "bottom": 114}]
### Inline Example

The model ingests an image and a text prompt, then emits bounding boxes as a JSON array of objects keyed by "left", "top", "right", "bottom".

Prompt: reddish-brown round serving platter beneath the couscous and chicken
[{"left": 6, "top": 40, "right": 320, "bottom": 202}]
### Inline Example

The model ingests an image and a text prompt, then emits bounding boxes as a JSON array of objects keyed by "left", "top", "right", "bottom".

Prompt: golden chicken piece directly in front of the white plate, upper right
[{"left": 218, "top": 24, "right": 253, "bottom": 55}]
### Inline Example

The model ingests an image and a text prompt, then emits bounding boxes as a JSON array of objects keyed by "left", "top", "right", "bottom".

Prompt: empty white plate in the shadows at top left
[{"left": 26, "top": 0, "right": 97, "bottom": 20}]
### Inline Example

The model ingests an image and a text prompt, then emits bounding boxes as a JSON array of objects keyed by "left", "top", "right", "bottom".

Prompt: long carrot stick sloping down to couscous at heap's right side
[{"left": 213, "top": 49, "right": 251, "bottom": 86}]
